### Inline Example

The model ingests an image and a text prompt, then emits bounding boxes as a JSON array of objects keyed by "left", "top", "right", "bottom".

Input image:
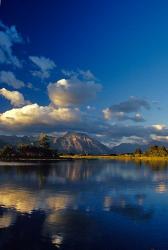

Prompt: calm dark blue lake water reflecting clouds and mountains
[{"left": 0, "top": 160, "right": 168, "bottom": 250}]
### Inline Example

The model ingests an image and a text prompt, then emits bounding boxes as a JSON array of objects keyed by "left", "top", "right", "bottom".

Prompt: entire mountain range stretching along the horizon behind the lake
[{"left": 0, "top": 132, "right": 168, "bottom": 155}]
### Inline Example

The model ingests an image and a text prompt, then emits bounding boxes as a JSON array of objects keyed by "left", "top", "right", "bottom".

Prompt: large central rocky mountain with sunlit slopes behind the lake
[{"left": 54, "top": 132, "right": 110, "bottom": 155}]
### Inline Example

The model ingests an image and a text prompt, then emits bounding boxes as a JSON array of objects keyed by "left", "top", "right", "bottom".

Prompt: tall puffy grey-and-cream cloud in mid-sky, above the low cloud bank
[{"left": 48, "top": 78, "right": 101, "bottom": 107}]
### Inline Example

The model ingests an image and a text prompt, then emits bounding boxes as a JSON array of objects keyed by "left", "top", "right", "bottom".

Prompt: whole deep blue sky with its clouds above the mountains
[{"left": 0, "top": 0, "right": 168, "bottom": 145}]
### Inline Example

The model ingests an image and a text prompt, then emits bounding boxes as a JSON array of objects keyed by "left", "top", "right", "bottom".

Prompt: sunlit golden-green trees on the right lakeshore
[{"left": 133, "top": 145, "right": 168, "bottom": 157}]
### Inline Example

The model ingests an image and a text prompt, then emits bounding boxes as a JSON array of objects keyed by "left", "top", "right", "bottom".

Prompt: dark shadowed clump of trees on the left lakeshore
[{"left": 0, "top": 134, "right": 58, "bottom": 160}]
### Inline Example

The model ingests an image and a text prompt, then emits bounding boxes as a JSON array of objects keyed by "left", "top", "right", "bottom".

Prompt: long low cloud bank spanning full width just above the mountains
[{"left": 0, "top": 97, "right": 168, "bottom": 146}]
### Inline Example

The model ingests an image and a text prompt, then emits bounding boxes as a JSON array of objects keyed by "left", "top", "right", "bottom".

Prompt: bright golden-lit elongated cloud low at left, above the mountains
[{"left": 0, "top": 103, "right": 79, "bottom": 131}]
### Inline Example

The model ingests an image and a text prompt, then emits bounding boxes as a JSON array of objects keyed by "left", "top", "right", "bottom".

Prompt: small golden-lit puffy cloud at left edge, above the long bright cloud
[{"left": 0, "top": 88, "right": 28, "bottom": 107}]
